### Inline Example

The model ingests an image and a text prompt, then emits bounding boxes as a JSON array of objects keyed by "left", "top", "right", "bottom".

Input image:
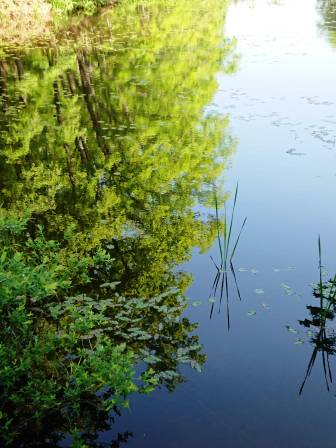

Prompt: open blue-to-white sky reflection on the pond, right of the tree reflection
[{"left": 110, "top": 0, "right": 336, "bottom": 448}]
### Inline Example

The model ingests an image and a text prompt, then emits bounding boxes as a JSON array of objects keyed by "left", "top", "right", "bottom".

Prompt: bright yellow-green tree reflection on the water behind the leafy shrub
[{"left": 0, "top": 0, "right": 234, "bottom": 446}]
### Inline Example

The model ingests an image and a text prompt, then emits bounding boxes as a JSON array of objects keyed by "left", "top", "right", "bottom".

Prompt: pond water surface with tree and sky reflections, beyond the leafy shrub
[{"left": 0, "top": 0, "right": 336, "bottom": 448}]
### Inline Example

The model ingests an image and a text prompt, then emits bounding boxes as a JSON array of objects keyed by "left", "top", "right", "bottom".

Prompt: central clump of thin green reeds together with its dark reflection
[{"left": 209, "top": 182, "right": 247, "bottom": 330}]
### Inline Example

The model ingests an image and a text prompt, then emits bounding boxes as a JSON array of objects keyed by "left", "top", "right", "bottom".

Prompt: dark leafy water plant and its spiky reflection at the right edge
[{"left": 299, "top": 278, "right": 336, "bottom": 394}]
